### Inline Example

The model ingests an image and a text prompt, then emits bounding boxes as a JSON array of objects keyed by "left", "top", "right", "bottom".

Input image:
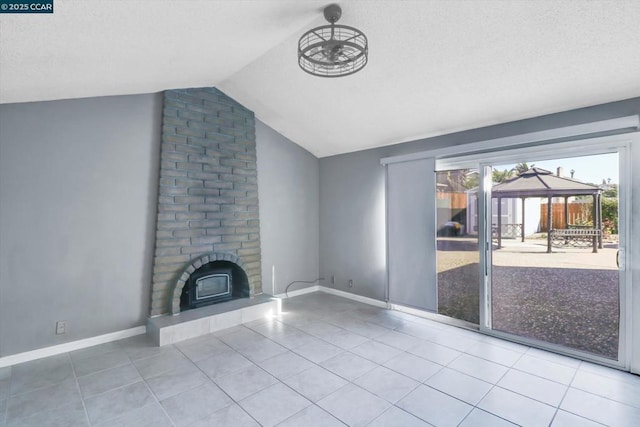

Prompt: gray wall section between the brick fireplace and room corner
[{"left": 256, "top": 120, "right": 322, "bottom": 294}]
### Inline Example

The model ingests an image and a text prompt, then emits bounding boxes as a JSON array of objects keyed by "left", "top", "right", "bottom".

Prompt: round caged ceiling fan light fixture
[{"left": 298, "top": 4, "right": 369, "bottom": 77}]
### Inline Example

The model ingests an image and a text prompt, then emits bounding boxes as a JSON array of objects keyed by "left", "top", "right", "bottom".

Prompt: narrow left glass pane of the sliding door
[{"left": 436, "top": 169, "right": 480, "bottom": 324}]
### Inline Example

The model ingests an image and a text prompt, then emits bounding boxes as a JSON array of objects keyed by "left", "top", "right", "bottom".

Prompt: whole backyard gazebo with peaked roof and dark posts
[{"left": 491, "top": 167, "right": 602, "bottom": 253}]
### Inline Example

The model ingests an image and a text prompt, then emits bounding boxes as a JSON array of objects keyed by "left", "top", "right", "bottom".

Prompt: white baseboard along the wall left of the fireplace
[{"left": 0, "top": 326, "right": 147, "bottom": 368}]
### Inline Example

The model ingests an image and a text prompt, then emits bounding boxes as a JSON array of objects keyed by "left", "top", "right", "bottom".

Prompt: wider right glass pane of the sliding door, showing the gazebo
[{"left": 487, "top": 153, "right": 621, "bottom": 360}]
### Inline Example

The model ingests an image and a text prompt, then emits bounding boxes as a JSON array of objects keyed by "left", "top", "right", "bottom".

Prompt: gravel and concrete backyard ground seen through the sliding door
[{"left": 437, "top": 238, "right": 619, "bottom": 359}]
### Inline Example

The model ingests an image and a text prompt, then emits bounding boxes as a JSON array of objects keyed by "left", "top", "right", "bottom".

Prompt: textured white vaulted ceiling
[{"left": 0, "top": 0, "right": 640, "bottom": 157}]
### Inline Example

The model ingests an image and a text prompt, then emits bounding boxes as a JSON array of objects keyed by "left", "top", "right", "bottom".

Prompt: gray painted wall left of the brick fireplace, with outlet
[{"left": 0, "top": 95, "right": 162, "bottom": 357}]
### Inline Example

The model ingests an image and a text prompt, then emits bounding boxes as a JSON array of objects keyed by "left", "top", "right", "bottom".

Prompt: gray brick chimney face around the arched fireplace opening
[{"left": 151, "top": 88, "right": 262, "bottom": 316}]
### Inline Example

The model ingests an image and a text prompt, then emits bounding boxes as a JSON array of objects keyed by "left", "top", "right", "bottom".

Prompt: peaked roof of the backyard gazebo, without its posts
[{"left": 491, "top": 167, "right": 601, "bottom": 198}]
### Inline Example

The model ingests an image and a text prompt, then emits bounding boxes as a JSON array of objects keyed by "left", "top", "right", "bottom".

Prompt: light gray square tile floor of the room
[{"left": 0, "top": 293, "right": 640, "bottom": 427}]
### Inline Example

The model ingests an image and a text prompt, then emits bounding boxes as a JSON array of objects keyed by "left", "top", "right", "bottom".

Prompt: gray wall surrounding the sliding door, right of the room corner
[{"left": 320, "top": 98, "right": 640, "bottom": 371}]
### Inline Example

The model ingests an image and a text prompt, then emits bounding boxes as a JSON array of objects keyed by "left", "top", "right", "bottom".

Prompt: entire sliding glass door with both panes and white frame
[{"left": 436, "top": 142, "right": 629, "bottom": 366}]
